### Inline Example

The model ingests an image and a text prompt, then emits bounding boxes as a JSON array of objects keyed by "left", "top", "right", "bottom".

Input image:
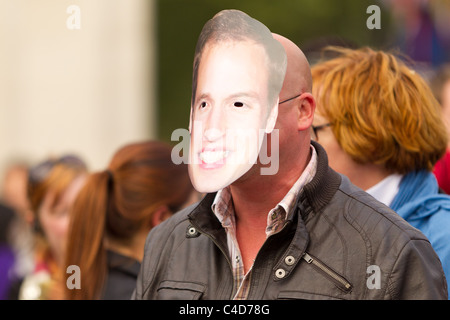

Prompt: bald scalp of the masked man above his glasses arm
[{"left": 272, "top": 33, "right": 312, "bottom": 101}]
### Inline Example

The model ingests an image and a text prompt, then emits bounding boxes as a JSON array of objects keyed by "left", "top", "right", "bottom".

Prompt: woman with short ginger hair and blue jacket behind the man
[{"left": 312, "top": 48, "right": 450, "bottom": 296}]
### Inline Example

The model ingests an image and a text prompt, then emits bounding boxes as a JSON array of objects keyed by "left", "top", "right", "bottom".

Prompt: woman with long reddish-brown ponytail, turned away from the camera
[{"left": 66, "top": 141, "right": 194, "bottom": 300}]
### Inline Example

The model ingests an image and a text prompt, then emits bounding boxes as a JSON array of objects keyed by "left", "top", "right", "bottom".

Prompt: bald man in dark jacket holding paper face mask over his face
[{"left": 133, "top": 10, "right": 447, "bottom": 300}]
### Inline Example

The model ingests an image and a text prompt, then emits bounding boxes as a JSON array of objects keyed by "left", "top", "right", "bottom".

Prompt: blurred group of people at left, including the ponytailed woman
[{"left": 0, "top": 141, "right": 199, "bottom": 300}]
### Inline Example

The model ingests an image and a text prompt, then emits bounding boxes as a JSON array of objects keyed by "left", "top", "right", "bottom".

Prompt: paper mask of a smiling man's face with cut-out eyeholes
[{"left": 189, "top": 10, "right": 286, "bottom": 192}]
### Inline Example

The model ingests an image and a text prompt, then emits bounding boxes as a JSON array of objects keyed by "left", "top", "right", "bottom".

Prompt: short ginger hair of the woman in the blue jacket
[{"left": 312, "top": 48, "right": 447, "bottom": 174}]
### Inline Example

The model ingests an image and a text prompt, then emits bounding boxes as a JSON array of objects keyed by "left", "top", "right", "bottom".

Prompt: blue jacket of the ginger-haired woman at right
[{"left": 390, "top": 170, "right": 450, "bottom": 296}]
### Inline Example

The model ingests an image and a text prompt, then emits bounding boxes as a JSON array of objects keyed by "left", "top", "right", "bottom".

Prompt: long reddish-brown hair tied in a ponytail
[{"left": 66, "top": 141, "right": 193, "bottom": 299}]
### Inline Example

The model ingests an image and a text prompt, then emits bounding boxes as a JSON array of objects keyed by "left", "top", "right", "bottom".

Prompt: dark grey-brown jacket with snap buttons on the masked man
[{"left": 133, "top": 143, "right": 447, "bottom": 300}]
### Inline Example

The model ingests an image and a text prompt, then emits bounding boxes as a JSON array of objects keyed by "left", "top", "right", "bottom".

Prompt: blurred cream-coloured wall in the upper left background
[{"left": 0, "top": 0, "right": 157, "bottom": 186}]
